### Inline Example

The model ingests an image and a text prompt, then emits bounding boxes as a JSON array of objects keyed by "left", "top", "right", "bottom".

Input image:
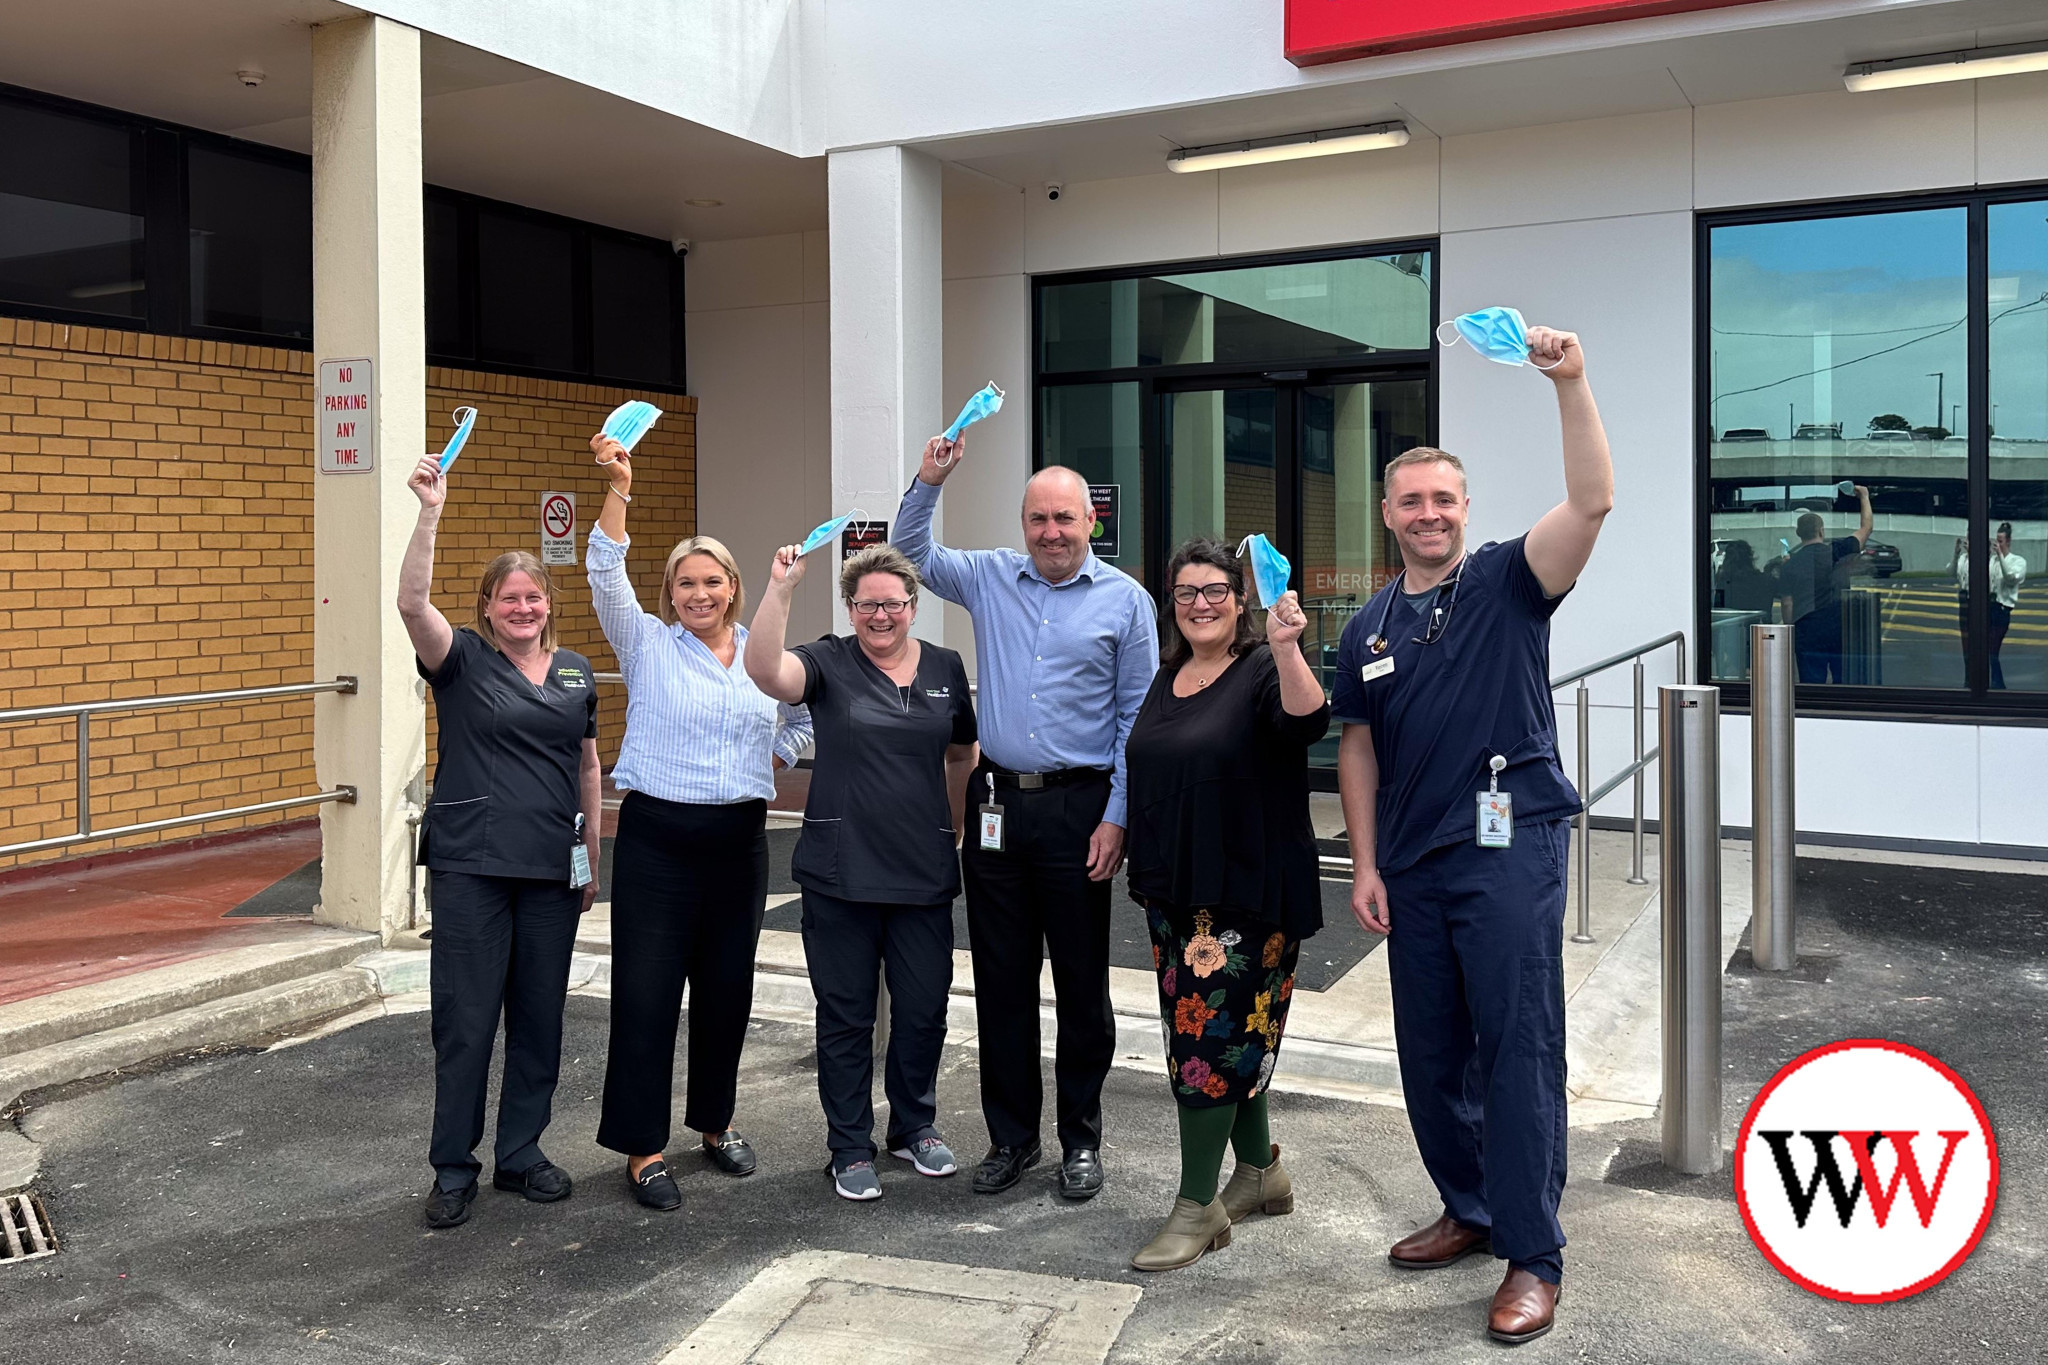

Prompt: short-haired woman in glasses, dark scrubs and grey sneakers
[{"left": 748, "top": 544, "right": 975, "bottom": 1199}]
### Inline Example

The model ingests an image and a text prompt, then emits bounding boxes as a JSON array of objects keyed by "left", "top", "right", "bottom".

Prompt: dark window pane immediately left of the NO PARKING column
[{"left": 184, "top": 143, "right": 313, "bottom": 338}]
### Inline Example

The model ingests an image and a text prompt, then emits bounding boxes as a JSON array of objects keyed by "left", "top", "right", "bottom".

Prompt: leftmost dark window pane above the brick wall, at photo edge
[{"left": 0, "top": 104, "right": 145, "bottom": 317}]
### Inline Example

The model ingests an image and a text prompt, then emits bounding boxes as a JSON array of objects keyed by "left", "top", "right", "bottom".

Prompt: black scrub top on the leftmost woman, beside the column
[{"left": 414, "top": 626, "right": 598, "bottom": 882}]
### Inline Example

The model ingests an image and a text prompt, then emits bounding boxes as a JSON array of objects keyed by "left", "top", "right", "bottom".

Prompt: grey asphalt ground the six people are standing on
[{"left": 0, "top": 860, "right": 2048, "bottom": 1365}]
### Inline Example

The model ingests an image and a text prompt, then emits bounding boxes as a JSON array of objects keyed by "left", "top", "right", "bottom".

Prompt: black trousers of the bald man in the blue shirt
[{"left": 961, "top": 765, "right": 1116, "bottom": 1150}]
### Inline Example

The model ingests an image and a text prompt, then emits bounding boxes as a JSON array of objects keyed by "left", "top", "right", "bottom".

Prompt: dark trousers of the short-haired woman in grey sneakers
[{"left": 803, "top": 886, "right": 952, "bottom": 1171}]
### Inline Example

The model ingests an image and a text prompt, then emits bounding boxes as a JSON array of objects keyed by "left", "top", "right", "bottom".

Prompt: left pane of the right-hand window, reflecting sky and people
[{"left": 1708, "top": 209, "right": 1970, "bottom": 688}]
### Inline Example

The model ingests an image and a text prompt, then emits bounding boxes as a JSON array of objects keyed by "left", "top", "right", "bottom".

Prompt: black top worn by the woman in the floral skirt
[{"left": 1124, "top": 643, "right": 1329, "bottom": 939}]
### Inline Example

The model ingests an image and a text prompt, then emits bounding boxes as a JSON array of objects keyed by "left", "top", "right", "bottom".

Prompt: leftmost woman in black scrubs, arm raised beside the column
[{"left": 397, "top": 454, "right": 602, "bottom": 1228}]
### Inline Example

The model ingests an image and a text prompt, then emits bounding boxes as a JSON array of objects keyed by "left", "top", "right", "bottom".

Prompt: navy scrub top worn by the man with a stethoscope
[{"left": 1329, "top": 536, "right": 1579, "bottom": 872}]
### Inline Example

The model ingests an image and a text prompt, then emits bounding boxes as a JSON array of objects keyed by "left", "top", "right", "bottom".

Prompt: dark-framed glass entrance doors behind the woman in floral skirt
[{"left": 1155, "top": 377, "right": 1430, "bottom": 769}]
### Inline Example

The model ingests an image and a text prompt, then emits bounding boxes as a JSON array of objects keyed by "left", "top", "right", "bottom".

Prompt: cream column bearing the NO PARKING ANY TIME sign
[{"left": 313, "top": 14, "right": 426, "bottom": 939}]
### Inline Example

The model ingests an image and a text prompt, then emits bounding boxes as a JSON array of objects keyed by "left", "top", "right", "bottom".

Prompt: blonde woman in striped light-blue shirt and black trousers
[{"left": 584, "top": 436, "right": 811, "bottom": 1209}]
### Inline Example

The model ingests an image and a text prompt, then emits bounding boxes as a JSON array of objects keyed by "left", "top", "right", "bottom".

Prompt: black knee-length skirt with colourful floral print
[{"left": 1145, "top": 900, "right": 1300, "bottom": 1109}]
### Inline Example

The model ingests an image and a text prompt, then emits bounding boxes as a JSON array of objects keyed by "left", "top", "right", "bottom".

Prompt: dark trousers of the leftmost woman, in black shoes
[{"left": 428, "top": 870, "right": 584, "bottom": 1189}]
